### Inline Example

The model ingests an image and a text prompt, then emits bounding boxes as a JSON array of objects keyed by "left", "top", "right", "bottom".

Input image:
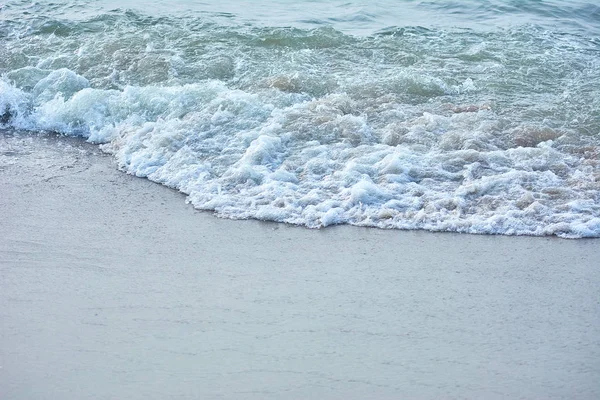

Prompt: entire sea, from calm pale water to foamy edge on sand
[{"left": 0, "top": 0, "right": 600, "bottom": 238}]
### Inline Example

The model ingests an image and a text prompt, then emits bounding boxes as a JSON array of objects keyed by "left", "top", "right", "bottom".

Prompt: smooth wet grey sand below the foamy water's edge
[{"left": 0, "top": 132, "right": 600, "bottom": 400}]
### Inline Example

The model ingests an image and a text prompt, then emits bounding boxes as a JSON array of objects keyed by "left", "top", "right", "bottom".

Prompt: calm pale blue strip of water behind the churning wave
[{"left": 3, "top": 0, "right": 600, "bottom": 35}]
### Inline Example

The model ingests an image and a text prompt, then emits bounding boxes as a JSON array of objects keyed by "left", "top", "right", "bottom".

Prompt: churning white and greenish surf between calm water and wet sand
[{"left": 0, "top": 20, "right": 600, "bottom": 237}]
